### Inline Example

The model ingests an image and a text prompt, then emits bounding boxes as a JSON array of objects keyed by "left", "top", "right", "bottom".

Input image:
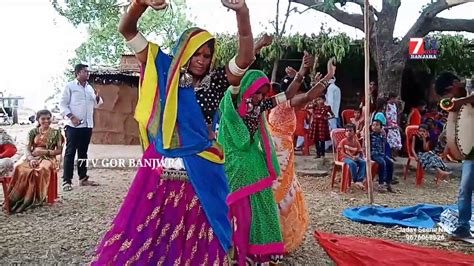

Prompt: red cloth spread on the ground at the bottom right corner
[{"left": 315, "top": 231, "right": 474, "bottom": 266}]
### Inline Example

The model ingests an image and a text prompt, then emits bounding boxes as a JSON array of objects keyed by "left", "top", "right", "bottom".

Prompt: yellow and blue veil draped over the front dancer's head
[{"left": 135, "top": 28, "right": 232, "bottom": 251}]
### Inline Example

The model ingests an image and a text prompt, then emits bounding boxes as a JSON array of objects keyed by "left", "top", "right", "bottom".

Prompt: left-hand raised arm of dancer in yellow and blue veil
[{"left": 118, "top": 0, "right": 168, "bottom": 64}]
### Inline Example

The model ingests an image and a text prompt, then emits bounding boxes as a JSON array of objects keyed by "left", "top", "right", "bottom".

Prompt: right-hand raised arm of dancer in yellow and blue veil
[{"left": 221, "top": 0, "right": 256, "bottom": 87}]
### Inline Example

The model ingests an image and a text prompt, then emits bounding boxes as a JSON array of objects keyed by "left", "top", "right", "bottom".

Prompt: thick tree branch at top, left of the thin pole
[{"left": 291, "top": 0, "right": 364, "bottom": 31}]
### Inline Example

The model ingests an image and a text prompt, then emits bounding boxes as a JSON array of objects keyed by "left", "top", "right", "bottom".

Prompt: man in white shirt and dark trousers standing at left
[{"left": 60, "top": 64, "right": 103, "bottom": 191}]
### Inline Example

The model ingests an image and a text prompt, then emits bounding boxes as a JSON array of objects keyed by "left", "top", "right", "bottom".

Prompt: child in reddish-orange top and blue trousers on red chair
[{"left": 337, "top": 124, "right": 366, "bottom": 189}]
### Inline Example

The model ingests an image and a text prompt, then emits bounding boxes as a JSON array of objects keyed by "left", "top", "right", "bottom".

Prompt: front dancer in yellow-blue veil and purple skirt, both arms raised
[{"left": 92, "top": 0, "right": 262, "bottom": 265}]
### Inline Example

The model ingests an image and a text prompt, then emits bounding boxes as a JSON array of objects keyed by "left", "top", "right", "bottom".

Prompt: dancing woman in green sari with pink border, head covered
[{"left": 218, "top": 53, "right": 322, "bottom": 265}]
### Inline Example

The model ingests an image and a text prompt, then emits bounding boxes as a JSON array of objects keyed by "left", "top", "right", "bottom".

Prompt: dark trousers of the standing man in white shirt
[{"left": 63, "top": 126, "right": 92, "bottom": 184}]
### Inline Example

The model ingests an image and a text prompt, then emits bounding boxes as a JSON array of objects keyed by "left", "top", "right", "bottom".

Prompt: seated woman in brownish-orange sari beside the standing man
[{"left": 8, "top": 110, "right": 63, "bottom": 213}]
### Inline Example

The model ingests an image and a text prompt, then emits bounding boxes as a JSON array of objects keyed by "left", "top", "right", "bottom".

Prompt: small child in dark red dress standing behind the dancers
[{"left": 309, "top": 96, "right": 334, "bottom": 158}]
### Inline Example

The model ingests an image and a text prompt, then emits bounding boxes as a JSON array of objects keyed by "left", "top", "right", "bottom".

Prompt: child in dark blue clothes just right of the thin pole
[{"left": 370, "top": 120, "right": 393, "bottom": 192}]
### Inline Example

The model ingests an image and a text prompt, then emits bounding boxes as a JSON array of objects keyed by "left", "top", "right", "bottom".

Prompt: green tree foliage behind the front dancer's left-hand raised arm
[{"left": 52, "top": 0, "right": 193, "bottom": 68}]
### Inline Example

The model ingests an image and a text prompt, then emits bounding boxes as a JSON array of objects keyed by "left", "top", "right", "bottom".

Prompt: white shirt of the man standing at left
[{"left": 59, "top": 79, "right": 104, "bottom": 128}]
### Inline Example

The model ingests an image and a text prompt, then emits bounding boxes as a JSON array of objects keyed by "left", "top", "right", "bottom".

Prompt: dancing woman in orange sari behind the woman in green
[{"left": 268, "top": 60, "right": 336, "bottom": 252}]
